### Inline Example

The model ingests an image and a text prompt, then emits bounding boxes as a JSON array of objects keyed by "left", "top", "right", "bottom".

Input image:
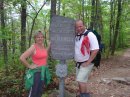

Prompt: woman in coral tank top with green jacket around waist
[{"left": 20, "top": 31, "right": 50, "bottom": 97}]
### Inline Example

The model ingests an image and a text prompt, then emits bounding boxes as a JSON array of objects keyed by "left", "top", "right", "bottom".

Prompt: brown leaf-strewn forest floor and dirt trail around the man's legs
[{"left": 49, "top": 49, "right": 130, "bottom": 97}]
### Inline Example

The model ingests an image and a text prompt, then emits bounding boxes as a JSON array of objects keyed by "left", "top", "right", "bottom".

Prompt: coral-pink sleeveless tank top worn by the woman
[{"left": 32, "top": 44, "right": 48, "bottom": 66}]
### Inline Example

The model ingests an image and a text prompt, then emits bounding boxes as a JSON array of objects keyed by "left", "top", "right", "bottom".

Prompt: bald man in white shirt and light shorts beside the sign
[{"left": 75, "top": 20, "right": 99, "bottom": 97}]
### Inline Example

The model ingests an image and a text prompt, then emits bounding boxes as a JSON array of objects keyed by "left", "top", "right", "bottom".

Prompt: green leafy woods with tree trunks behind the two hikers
[{"left": 0, "top": 0, "right": 130, "bottom": 97}]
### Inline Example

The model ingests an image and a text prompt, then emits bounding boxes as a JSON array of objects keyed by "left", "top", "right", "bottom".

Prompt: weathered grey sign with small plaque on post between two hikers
[{"left": 50, "top": 15, "right": 75, "bottom": 97}]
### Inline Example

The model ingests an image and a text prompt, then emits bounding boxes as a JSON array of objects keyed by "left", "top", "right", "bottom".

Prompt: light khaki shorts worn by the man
[{"left": 76, "top": 63, "right": 94, "bottom": 83}]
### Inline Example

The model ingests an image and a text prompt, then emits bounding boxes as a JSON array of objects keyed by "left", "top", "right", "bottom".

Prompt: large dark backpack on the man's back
[{"left": 84, "top": 29, "right": 102, "bottom": 68}]
